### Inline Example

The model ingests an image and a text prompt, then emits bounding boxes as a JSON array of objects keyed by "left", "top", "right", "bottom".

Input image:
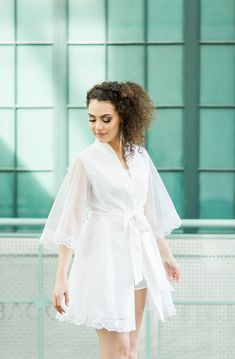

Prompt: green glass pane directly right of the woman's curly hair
[{"left": 148, "top": 109, "right": 183, "bottom": 167}]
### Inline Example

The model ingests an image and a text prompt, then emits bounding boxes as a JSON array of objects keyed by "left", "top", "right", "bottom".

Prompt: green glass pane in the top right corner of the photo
[{"left": 201, "top": 0, "right": 235, "bottom": 40}]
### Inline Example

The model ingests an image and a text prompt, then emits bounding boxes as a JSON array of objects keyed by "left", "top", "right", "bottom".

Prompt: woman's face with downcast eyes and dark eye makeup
[{"left": 88, "top": 100, "right": 122, "bottom": 142}]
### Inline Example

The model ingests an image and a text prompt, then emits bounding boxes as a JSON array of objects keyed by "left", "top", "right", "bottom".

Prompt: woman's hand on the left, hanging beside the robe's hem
[{"left": 52, "top": 275, "right": 69, "bottom": 314}]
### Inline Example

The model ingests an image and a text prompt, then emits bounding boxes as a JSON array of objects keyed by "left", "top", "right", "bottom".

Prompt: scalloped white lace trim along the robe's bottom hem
[{"left": 55, "top": 309, "right": 136, "bottom": 333}]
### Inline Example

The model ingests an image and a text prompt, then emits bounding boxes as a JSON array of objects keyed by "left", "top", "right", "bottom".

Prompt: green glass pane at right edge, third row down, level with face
[{"left": 199, "top": 109, "right": 235, "bottom": 167}]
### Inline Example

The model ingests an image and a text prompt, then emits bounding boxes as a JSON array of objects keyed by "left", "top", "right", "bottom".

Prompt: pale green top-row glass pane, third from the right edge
[{"left": 108, "top": 0, "right": 144, "bottom": 41}]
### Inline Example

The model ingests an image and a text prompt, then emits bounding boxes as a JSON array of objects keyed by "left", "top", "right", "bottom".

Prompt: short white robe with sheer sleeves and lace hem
[{"left": 39, "top": 139, "right": 182, "bottom": 332}]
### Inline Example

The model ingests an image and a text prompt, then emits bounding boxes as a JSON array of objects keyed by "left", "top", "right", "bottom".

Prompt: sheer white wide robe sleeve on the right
[{"left": 144, "top": 148, "right": 182, "bottom": 240}]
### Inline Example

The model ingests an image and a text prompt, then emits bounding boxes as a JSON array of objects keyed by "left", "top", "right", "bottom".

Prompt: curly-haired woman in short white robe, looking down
[{"left": 40, "top": 81, "right": 182, "bottom": 359}]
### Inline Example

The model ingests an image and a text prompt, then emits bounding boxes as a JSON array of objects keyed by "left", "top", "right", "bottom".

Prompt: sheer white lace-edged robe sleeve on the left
[{"left": 39, "top": 156, "right": 90, "bottom": 254}]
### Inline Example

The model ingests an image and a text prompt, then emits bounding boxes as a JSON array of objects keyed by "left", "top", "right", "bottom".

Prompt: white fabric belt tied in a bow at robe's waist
[{"left": 87, "top": 207, "right": 151, "bottom": 285}]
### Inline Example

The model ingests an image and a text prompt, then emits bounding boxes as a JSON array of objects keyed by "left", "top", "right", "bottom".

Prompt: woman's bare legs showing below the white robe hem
[{"left": 96, "top": 288, "right": 147, "bottom": 359}]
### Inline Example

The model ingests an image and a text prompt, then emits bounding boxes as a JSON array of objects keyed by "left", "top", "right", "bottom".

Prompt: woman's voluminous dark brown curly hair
[{"left": 86, "top": 81, "right": 155, "bottom": 160}]
